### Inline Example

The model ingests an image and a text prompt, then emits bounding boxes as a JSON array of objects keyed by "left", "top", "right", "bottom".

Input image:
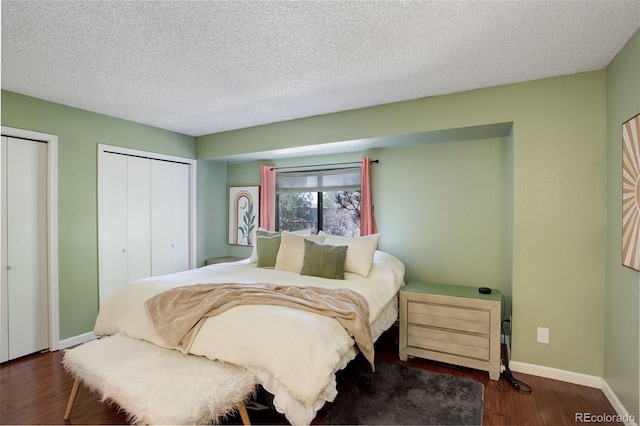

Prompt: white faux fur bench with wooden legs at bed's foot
[{"left": 63, "top": 334, "right": 256, "bottom": 425}]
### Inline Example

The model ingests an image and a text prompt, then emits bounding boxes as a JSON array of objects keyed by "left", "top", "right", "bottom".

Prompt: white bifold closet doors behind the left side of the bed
[{"left": 98, "top": 148, "right": 195, "bottom": 303}]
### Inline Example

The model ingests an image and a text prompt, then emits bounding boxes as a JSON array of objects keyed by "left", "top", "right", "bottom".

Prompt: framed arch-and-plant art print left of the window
[{"left": 229, "top": 186, "right": 260, "bottom": 246}]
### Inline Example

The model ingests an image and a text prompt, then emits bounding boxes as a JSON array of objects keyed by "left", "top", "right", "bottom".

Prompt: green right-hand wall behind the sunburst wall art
[{"left": 604, "top": 31, "right": 640, "bottom": 422}]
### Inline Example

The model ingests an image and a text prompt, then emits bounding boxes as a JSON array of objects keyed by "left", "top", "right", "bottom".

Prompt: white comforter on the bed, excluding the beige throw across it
[{"left": 94, "top": 251, "right": 404, "bottom": 424}]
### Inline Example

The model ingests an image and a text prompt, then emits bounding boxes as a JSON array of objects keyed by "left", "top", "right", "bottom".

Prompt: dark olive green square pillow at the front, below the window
[{"left": 300, "top": 240, "right": 349, "bottom": 280}]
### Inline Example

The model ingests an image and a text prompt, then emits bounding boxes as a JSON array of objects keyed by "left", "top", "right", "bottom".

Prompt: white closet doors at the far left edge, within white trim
[{"left": 0, "top": 137, "right": 49, "bottom": 360}]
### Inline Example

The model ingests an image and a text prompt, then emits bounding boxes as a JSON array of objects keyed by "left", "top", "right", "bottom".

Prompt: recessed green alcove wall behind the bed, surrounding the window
[{"left": 221, "top": 139, "right": 511, "bottom": 302}]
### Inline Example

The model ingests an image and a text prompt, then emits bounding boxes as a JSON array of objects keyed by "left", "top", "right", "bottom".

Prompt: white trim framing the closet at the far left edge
[{"left": 2, "top": 126, "right": 60, "bottom": 351}]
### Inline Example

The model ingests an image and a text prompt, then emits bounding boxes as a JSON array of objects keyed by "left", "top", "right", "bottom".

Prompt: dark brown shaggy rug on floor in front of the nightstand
[{"left": 322, "top": 361, "right": 484, "bottom": 425}]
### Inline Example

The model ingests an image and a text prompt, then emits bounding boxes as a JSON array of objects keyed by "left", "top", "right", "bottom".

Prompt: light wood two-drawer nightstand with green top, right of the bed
[{"left": 399, "top": 282, "right": 502, "bottom": 380}]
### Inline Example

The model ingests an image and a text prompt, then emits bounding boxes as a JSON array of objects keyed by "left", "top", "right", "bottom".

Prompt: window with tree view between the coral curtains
[{"left": 276, "top": 168, "right": 360, "bottom": 237}]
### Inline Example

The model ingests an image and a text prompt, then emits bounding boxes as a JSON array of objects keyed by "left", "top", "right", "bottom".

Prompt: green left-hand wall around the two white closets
[{"left": 2, "top": 91, "right": 226, "bottom": 339}]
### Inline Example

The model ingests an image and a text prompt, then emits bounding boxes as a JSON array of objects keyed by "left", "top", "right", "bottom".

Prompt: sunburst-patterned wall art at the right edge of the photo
[{"left": 622, "top": 114, "right": 640, "bottom": 271}]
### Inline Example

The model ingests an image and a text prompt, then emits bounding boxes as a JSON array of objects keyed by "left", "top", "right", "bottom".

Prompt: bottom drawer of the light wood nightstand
[{"left": 407, "top": 325, "right": 490, "bottom": 361}]
